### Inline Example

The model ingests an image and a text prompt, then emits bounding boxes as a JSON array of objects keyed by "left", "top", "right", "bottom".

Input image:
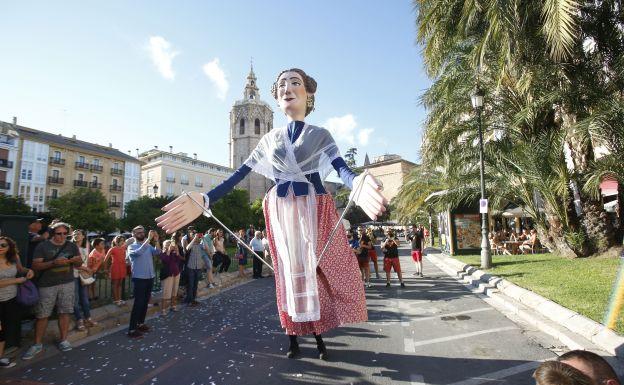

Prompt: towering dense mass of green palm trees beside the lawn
[{"left": 414, "top": 0, "right": 624, "bottom": 255}]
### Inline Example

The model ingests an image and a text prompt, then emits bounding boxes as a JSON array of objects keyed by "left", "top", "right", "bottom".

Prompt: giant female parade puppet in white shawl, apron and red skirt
[{"left": 156, "top": 68, "right": 387, "bottom": 359}]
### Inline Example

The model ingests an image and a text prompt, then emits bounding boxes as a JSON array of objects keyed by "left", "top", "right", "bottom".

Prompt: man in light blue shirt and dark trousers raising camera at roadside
[{"left": 128, "top": 226, "right": 160, "bottom": 338}]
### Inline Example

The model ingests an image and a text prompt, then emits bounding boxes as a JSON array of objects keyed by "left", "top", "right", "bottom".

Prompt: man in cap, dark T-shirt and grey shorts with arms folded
[{"left": 22, "top": 222, "right": 82, "bottom": 360}]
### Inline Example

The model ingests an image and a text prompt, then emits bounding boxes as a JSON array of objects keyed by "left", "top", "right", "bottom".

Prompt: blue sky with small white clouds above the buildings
[{"left": 0, "top": 0, "right": 429, "bottom": 165}]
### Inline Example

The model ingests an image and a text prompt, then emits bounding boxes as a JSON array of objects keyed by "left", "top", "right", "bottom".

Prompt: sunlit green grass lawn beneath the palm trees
[{"left": 454, "top": 254, "right": 624, "bottom": 334}]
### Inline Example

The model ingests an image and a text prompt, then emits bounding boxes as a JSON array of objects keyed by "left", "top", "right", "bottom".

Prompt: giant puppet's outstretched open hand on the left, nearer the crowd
[{"left": 156, "top": 191, "right": 204, "bottom": 234}]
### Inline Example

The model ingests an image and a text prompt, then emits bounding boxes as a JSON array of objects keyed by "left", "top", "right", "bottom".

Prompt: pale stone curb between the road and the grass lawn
[{"left": 427, "top": 253, "right": 624, "bottom": 359}]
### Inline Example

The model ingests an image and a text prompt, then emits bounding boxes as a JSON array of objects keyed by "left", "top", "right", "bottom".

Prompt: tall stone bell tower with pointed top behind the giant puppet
[{"left": 230, "top": 65, "right": 273, "bottom": 201}]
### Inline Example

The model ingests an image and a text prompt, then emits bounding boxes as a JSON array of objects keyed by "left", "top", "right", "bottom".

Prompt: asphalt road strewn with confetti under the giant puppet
[{"left": 0, "top": 248, "right": 555, "bottom": 385}]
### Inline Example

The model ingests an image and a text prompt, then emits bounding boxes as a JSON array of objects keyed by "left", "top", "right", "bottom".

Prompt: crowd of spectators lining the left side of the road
[{"left": 0, "top": 219, "right": 270, "bottom": 368}]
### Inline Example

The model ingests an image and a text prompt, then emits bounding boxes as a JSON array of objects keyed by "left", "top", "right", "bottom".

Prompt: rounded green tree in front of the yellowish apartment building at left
[{"left": 50, "top": 188, "right": 116, "bottom": 232}]
